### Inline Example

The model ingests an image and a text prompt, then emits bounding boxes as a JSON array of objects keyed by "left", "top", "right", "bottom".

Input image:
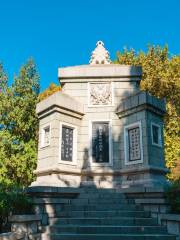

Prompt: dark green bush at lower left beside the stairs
[{"left": 0, "top": 184, "right": 33, "bottom": 232}]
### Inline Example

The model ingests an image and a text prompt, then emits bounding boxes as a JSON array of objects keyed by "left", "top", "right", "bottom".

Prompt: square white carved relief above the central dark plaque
[{"left": 89, "top": 83, "right": 112, "bottom": 105}]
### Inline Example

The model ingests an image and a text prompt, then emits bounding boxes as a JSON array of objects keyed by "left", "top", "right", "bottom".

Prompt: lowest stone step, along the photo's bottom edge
[{"left": 42, "top": 233, "right": 176, "bottom": 240}]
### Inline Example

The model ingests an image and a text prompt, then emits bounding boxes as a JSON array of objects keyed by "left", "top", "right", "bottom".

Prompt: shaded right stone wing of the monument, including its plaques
[{"left": 117, "top": 92, "right": 167, "bottom": 187}]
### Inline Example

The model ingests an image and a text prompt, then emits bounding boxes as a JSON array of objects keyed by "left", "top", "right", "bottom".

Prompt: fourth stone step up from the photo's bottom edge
[{"left": 48, "top": 209, "right": 150, "bottom": 217}]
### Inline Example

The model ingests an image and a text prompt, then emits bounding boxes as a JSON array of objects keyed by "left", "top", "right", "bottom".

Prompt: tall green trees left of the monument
[{"left": 0, "top": 59, "right": 39, "bottom": 186}]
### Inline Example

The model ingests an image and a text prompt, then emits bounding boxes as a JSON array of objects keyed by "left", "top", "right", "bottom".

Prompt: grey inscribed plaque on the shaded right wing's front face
[{"left": 128, "top": 127, "right": 141, "bottom": 161}]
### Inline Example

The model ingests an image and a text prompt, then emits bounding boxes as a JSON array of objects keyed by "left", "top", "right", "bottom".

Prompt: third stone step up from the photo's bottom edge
[{"left": 49, "top": 217, "right": 157, "bottom": 226}]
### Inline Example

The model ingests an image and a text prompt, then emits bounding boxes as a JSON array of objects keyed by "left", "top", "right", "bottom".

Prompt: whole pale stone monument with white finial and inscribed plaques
[{"left": 32, "top": 41, "right": 167, "bottom": 188}]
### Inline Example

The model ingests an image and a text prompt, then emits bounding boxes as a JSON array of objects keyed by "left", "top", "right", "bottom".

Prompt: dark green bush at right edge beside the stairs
[{"left": 166, "top": 180, "right": 180, "bottom": 213}]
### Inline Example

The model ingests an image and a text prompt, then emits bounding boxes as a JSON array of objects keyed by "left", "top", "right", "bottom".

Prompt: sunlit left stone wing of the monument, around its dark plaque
[{"left": 31, "top": 92, "right": 84, "bottom": 187}]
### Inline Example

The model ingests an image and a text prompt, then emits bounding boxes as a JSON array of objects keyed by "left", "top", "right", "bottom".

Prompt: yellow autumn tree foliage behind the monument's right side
[{"left": 115, "top": 46, "right": 180, "bottom": 179}]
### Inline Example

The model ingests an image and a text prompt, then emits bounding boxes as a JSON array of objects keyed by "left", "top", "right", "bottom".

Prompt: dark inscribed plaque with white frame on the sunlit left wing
[{"left": 61, "top": 126, "right": 73, "bottom": 161}]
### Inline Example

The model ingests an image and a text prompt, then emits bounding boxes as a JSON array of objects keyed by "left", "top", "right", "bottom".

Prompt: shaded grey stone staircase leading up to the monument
[{"left": 39, "top": 188, "right": 176, "bottom": 240}]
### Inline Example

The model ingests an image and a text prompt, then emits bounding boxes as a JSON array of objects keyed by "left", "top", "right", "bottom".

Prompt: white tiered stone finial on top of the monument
[{"left": 89, "top": 41, "right": 111, "bottom": 65}]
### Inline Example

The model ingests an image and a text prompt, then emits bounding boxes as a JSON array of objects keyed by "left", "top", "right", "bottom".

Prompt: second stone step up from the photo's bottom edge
[{"left": 46, "top": 225, "right": 167, "bottom": 234}]
